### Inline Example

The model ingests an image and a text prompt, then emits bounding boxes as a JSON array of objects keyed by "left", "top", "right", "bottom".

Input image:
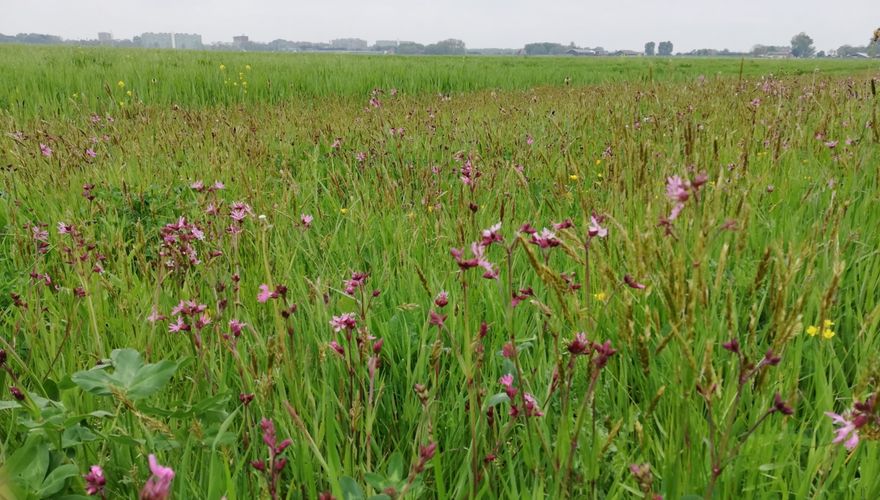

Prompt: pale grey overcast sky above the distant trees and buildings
[{"left": 0, "top": 0, "right": 880, "bottom": 51}]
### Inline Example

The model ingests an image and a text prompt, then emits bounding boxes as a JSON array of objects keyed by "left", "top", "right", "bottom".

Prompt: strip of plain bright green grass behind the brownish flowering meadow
[{"left": 0, "top": 46, "right": 880, "bottom": 117}]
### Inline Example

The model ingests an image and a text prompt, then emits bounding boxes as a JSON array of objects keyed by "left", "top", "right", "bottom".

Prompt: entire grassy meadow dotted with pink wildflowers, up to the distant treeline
[{"left": 0, "top": 47, "right": 880, "bottom": 500}]
